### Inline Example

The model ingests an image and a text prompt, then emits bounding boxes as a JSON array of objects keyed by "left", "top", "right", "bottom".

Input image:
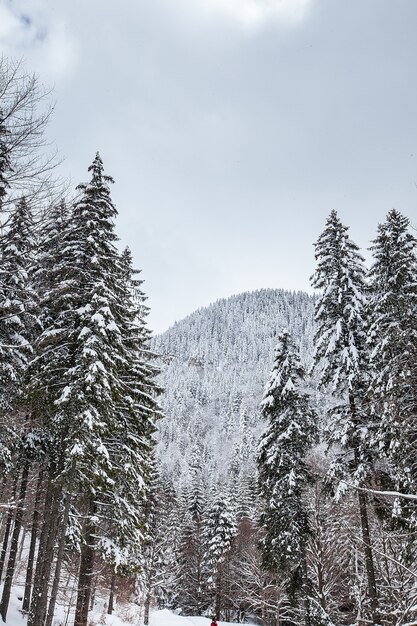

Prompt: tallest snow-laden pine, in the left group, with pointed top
[{"left": 29, "top": 154, "right": 160, "bottom": 626}]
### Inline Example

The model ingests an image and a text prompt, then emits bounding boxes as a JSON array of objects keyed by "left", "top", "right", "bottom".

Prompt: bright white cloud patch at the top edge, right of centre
[{"left": 194, "top": 0, "right": 312, "bottom": 26}]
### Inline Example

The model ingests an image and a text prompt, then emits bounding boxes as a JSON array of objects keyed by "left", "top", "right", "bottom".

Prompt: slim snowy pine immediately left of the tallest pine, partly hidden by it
[{"left": 23, "top": 200, "right": 72, "bottom": 626}]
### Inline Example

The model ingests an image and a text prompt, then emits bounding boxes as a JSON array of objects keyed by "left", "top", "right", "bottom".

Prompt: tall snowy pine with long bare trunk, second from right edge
[{"left": 311, "top": 211, "right": 378, "bottom": 624}]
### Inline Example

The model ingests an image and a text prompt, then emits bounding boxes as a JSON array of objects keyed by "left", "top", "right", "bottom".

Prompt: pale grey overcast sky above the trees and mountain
[{"left": 0, "top": 0, "right": 417, "bottom": 331}]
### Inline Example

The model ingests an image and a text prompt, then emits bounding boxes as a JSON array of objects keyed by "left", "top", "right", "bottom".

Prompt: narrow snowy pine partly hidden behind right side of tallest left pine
[{"left": 97, "top": 248, "right": 162, "bottom": 574}]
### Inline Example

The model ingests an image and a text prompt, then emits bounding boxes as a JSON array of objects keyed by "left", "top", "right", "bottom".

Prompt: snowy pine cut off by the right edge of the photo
[{"left": 368, "top": 209, "right": 417, "bottom": 524}]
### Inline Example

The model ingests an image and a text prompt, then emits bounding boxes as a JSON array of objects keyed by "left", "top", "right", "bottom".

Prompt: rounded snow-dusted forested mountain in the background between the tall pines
[{"left": 152, "top": 289, "right": 314, "bottom": 486}]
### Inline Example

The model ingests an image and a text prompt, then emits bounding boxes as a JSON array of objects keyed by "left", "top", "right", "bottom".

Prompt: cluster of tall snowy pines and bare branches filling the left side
[{"left": 0, "top": 59, "right": 161, "bottom": 626}]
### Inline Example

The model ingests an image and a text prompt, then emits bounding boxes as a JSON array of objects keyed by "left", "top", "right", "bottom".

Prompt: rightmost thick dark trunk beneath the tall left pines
[{"left": 74, "top": 500, "right": 95, "bottom": 626}]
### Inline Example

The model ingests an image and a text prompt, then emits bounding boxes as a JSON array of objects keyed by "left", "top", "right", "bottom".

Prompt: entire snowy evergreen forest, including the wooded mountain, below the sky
[{"left": 0, "top": 57, "right": 417, "bottom": 626}]
